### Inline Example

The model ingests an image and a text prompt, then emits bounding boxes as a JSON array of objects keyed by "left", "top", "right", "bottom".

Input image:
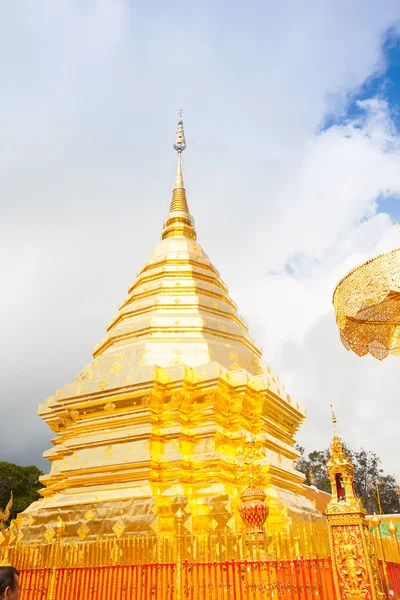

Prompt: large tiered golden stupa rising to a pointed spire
[{"left": 17, "top": 118, "right": 320, "bottom": 542}]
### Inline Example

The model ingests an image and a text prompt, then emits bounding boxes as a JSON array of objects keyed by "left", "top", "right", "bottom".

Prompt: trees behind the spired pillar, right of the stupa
[{"left": 296, "top": 446, "right": 400, "bottom": 514}]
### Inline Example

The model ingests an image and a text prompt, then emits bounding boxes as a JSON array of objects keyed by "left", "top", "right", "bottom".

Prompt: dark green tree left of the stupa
[{"left": 0, "top": 461, "right": 43, "bottom": 521}]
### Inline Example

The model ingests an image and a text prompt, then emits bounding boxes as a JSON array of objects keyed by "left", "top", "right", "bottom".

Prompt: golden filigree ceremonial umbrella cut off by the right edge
[{"left": 333, "top": 248, "right": 400, "bottom": 360}]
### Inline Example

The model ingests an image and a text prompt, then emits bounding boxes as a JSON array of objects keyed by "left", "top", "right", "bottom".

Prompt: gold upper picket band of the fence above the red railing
[{"left": 0, "top": 519, "right": 330, "bottom": 569}]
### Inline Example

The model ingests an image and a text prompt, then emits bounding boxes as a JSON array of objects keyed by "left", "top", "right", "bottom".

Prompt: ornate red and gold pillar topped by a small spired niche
[{"left": 325, "top": 411, "right": 388, "bottom": 600}]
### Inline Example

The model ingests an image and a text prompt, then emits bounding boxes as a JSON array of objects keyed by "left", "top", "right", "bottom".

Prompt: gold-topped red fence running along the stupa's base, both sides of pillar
[{"left": 0, "top": 518, "right": 400, "bottom": 600}]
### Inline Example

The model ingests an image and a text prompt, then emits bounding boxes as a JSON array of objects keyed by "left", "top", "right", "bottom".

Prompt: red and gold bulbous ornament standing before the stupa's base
[{"left": 239, "top": 486, "right": 272, "bottom": 557}]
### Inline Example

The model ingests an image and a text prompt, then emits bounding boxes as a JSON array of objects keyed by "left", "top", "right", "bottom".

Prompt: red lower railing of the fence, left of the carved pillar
[{"left": 20, "top": 558, "right": 335, "bottom": 600}]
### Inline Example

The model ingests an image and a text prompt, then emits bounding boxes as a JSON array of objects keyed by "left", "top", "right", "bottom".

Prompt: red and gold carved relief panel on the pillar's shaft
[{"left": 332, "top": 526, "right": 372, "bottom": 600}]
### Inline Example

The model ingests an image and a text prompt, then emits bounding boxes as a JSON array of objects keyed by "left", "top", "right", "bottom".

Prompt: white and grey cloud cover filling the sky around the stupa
[{"left": 0, "top": 0, "right": 400, "bottom": 475}]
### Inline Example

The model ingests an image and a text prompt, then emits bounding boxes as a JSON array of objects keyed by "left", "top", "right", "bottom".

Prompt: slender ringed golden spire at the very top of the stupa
[{"left": 162, "top": 110, "right": 196, "bottom": 240}]
